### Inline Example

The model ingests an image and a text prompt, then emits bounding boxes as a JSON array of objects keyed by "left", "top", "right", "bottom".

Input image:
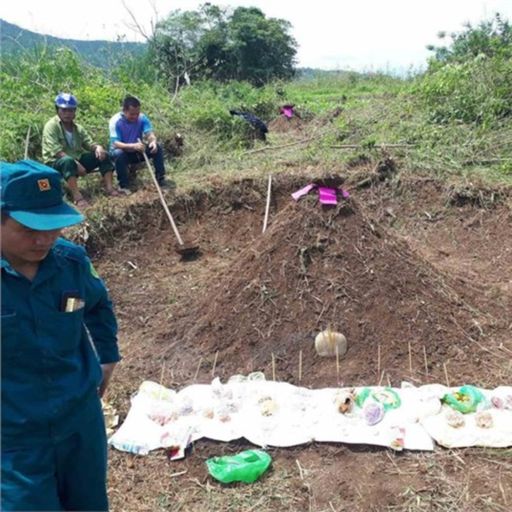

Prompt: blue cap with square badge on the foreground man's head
[{"left": 0, "top": 160, "right": 84, "bottom": 231}]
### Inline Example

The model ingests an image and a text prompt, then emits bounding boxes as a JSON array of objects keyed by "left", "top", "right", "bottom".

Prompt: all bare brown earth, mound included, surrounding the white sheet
[{"left": 89, "top": 173, "right": 512, "bottom": 512}]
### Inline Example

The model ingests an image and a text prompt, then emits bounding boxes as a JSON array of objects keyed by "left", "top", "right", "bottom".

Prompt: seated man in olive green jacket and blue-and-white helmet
[{"left": 42, "top": 93, "right": 120, "bottom": 207}]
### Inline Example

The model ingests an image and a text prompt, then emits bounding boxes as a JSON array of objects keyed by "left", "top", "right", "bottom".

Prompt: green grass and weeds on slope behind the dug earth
[{"left": 0, "top": 51, "right": 512, "bottom": 190}]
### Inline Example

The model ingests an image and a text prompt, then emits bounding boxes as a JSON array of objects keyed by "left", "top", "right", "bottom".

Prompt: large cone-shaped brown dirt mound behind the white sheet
[{"left": 167, "top": 197, "right": 484, "bottom": 387}]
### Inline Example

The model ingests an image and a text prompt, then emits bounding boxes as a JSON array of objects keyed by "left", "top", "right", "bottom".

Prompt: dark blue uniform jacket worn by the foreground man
[{"left": 1, "top": 239, "right": 120, "bottom": 449}]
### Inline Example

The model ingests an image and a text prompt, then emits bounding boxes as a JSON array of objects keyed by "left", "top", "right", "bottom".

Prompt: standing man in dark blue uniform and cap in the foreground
[{"left": 0, "top": 160, "right": 120, "bottom": 511}]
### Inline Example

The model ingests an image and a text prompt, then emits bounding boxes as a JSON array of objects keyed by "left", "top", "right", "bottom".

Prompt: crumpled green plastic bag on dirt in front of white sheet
[{"left": 206, "top": 450, "right": 272, "bottom": 484}]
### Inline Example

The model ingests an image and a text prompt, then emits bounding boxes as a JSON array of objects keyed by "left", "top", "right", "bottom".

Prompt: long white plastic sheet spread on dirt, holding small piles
[{"left": 109, "top": 374, "right": 512, "bottom": 455}]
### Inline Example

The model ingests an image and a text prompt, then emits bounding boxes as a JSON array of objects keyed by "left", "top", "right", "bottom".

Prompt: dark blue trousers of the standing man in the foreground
[{"left": 2, "top": 398, "right": 108, "bottom": 512}]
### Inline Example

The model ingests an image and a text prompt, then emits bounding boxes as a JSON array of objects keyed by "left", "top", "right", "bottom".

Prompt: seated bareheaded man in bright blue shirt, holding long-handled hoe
[{"left": 109, "top": 96, "right": 172, "bottom": 192}]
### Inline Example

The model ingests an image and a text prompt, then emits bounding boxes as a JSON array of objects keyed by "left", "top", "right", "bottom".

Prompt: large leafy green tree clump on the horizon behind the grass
[{"left": 150, "top": 3, "right": 297, "bottom": 88}]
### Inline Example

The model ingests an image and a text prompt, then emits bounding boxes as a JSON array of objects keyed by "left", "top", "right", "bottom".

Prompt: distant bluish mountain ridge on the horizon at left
[{"left": 0, "top": 19, "right": 147, "bottom": 68}]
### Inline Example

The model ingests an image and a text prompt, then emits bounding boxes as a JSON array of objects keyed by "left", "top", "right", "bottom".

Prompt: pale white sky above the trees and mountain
[{"left": 0, "top": 0, "right": 512, "bottom": 74}]
